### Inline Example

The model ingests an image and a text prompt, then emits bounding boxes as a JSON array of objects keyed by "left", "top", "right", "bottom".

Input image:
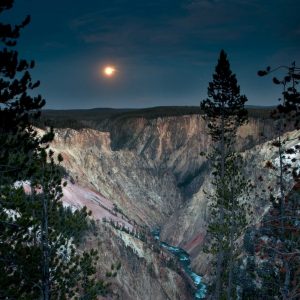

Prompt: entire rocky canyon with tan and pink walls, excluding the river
[{"left": 40, "top": 108, "right": 296, "bottom": 299}]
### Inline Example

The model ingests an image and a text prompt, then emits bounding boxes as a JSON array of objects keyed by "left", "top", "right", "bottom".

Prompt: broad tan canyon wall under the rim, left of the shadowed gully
[{"left": 52, "top": 116, "right": 210, "bottom": 226}]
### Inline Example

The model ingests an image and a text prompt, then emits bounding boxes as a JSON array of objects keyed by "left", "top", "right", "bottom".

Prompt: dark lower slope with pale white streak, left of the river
[{"left": 81, "top": 224, "right": 193, "bottom": 300}]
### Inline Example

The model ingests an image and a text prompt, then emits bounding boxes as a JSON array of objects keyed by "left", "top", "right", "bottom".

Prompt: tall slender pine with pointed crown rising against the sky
[{"left": 201, "top": 50, "right": 247, "bottom": 299}]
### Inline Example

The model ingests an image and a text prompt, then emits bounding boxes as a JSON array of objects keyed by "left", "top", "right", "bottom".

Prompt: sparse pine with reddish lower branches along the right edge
[{"left": 243, "top": 63, "right": 300, "bottom": 299}]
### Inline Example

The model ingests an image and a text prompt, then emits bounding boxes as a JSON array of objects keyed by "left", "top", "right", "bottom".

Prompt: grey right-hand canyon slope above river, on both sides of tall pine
[{"left": 162, "top": 130, "right": 300, "bottom": 274}]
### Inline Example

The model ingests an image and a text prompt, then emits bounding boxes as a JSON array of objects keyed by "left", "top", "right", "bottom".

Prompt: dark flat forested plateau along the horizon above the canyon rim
[{"left": 35, "top": 106, "right": 272, "bottom": 130}]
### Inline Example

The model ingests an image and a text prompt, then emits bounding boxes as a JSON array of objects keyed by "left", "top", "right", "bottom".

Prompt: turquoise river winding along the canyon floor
[{"left": 152, "top": 229, "right": 206, "bottom": 299}]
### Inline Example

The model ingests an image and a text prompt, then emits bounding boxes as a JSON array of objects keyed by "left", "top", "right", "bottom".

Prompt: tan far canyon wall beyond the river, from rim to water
[{"left": 45, "top": 115, "right": 288, "bottom": 282}]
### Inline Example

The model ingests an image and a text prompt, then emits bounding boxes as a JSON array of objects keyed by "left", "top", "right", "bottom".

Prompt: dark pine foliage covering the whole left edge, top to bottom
[{"left": 0, "top": 0, "right": 107, "bottom": 299}]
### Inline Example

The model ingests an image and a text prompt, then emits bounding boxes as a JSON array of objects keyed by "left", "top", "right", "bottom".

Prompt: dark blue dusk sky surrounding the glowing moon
[{"left": 4, "top": 0, "right": 300, "bottom": 109}]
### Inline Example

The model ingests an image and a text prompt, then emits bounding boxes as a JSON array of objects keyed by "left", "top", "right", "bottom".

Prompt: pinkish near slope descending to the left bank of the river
[{"left": 55, "top": 180, "right": 194, "bottom": 300}]
